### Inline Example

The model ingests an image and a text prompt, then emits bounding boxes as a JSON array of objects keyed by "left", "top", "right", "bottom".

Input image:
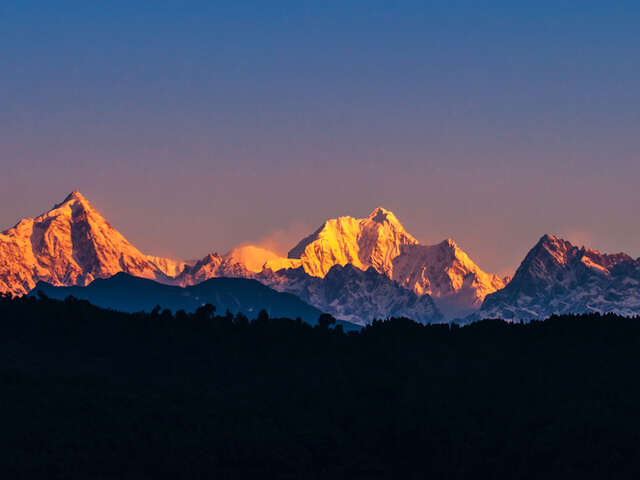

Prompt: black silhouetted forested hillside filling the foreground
[{"left": 0, "top": 298, "right": 640, "bottom": 479}]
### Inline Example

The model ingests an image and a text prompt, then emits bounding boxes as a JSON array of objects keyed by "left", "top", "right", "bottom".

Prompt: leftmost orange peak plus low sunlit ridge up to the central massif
[{"left": 0, "top": 191, "right": 297, "bottom": 295}]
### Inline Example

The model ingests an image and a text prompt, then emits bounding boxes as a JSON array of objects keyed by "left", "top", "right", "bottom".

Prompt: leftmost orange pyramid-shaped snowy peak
[{"left": 0, "top": 190, "right": 172, "bottom": 294}]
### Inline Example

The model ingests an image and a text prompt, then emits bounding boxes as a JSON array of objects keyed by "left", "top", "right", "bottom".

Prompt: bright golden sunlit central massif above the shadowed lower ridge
[{"left": 288, "top": 207, "right": 507, "bottom": 318}]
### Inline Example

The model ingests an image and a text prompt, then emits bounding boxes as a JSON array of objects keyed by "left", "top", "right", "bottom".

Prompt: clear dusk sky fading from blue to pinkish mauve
[{"left": 0, "top": 0, "right": 640, "bottom": 273}]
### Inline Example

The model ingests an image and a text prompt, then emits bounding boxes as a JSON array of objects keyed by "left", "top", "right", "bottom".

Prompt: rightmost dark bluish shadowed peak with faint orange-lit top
[{"left": 478, "top": 235, "right": 640, "bottom": 320}]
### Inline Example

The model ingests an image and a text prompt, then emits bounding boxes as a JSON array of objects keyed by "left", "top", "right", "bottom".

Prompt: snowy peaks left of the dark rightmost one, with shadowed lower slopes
[{"left": 0, "top": 191, "right": 496, "bottom": 324}]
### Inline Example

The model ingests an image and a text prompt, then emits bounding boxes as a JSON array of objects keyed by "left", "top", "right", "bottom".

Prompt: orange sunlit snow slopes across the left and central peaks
[{"left": 0, "top": 191, "right": 505, "bottom": 315}]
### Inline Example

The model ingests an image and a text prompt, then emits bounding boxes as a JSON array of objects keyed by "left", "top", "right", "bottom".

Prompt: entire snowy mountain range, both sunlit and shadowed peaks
[{"left": 0, "top": 191, "right": 640, "bottom": 324}]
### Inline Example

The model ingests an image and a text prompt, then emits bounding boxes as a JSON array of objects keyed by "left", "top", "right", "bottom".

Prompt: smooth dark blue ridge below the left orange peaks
[{"left": 31, "top": 273, "right": 360, "bottom": 324}]
